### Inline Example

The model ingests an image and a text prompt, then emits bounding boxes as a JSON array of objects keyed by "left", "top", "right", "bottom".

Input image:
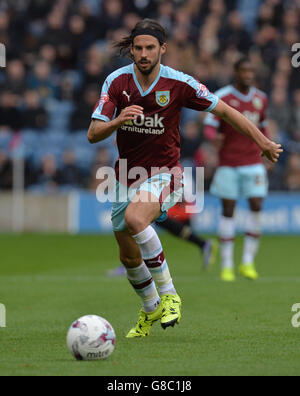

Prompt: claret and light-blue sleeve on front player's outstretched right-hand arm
[{"left": 183, "top": 77, "right": 219, "bottom": 112}]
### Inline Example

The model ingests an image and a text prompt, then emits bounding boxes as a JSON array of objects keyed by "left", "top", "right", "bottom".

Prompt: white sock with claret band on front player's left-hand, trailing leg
[{"left": 127, "top": 262, "right": 160, "bottom": 312}]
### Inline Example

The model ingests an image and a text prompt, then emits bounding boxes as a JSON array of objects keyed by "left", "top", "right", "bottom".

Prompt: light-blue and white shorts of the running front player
[{"left": 112, "top": 173, "right": 184, "bottom": 231}]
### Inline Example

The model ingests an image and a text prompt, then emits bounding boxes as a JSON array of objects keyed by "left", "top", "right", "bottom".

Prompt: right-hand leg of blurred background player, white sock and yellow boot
[{"left": 239, "top": 197, "right": 263, "bottom": 280}]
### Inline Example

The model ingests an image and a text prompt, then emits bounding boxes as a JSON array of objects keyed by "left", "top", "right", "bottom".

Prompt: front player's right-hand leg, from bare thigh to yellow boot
[{"left": 125, "top": 191, "right": 181, "bottom": 329}]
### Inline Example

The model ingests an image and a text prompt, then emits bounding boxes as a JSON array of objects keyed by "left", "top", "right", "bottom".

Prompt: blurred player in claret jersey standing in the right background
[{"left": 204, "top": 58, "right": 268, "bottom": 281}]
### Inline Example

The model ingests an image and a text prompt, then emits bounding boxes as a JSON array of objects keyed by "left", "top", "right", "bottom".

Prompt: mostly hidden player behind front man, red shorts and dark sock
[{"left": 107, "top": 203, "right": 218, "bottom": 276}]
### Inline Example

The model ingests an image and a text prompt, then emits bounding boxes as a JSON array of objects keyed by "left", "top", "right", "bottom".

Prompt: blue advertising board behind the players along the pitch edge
[{"left": 73, "top": 193, "right": 300, "bottom": 235}]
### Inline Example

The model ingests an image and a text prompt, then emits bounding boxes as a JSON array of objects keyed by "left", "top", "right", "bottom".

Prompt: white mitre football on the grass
[{"left": 67, "top": 315, "right": 116, "bottom": 360}]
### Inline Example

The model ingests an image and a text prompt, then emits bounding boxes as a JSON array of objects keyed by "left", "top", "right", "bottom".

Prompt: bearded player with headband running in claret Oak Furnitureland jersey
[{"left": 88, "top": 19, "right": 282, "bottom": 338}]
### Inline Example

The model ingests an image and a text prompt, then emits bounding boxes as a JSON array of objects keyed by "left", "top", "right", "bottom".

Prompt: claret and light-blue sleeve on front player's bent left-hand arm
[{"left": 92, "top": 76, "right": 117, "bottom": 122}]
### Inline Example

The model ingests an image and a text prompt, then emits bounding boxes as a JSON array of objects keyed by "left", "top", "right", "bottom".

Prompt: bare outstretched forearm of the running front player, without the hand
[{"left": 211, "top": 102, "right": 271, "bottom": 152}]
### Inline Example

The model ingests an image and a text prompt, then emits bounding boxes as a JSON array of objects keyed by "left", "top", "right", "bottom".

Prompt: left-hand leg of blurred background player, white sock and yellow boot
[{"left": 218, "top": 199, "right": 236, "bottom": 282}]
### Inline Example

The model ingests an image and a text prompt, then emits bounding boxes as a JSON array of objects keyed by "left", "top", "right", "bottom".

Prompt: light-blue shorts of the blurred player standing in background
[{"left": 210, "top": 164, "right": 269, "bottom": 201}]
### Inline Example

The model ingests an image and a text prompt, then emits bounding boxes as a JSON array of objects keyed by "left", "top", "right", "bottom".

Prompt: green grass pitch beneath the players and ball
[{"left": 0, "top": 234, "right": 300, "bottom": 376}]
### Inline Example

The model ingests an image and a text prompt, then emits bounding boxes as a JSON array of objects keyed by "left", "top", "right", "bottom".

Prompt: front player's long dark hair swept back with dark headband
[{"left": 113, "top": 18, "right": 167, "bottom": 58}]
